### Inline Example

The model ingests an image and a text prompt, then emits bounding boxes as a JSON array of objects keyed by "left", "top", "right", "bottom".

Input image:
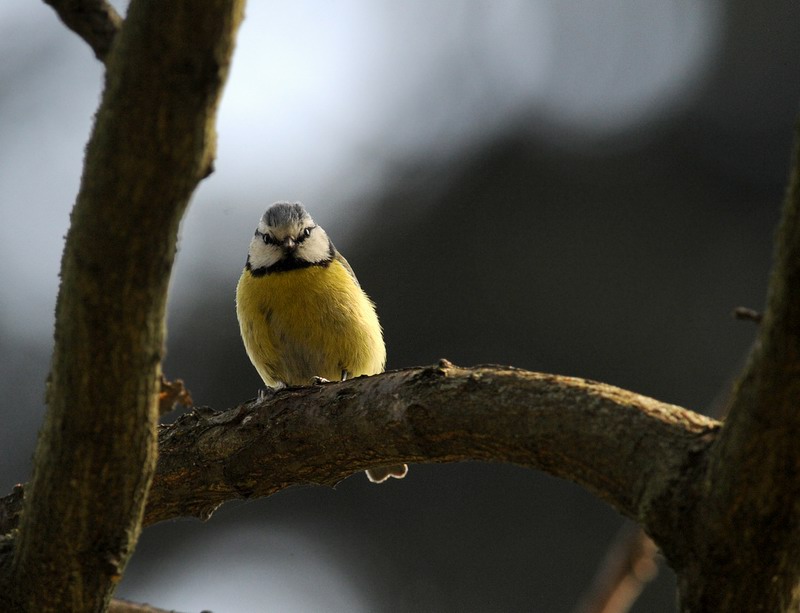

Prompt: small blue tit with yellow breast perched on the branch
[{"left": 231, "top": 202, "right": 408, "bottom": 483}]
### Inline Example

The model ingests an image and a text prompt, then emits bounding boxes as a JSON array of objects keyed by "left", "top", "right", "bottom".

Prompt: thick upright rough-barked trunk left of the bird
[{"left": 0, "top": 0, "right": 242, "bottom": 612}]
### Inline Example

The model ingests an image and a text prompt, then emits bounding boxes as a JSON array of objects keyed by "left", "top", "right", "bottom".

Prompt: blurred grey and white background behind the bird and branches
[{"left": 0, "top": 0, "right": 800, "bottom": 613}]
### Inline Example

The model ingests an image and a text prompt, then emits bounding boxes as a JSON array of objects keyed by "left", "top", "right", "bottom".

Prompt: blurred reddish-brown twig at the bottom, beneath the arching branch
[{"left": 575, "top": 525, "right": 658, "bottom": 613}]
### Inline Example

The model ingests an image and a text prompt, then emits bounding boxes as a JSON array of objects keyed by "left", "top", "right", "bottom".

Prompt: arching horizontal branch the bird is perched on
[{"left": 139, "top": 362, "right": 718, "bottom": 524}]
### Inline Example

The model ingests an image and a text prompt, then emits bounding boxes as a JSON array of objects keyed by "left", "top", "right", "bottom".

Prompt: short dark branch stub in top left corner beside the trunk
[{"left": 44, "top": 0, "right": 122, "bottom": 62}]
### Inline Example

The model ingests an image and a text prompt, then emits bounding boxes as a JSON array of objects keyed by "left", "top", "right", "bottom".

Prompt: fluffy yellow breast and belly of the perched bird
[{"left": 236, "top": 260, "right": 386, "bottom": 386}]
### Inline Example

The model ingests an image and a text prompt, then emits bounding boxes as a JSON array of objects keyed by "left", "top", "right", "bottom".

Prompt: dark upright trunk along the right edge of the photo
[{"left": 665, "top": 124, "right": 800, "bottom": 611}]
